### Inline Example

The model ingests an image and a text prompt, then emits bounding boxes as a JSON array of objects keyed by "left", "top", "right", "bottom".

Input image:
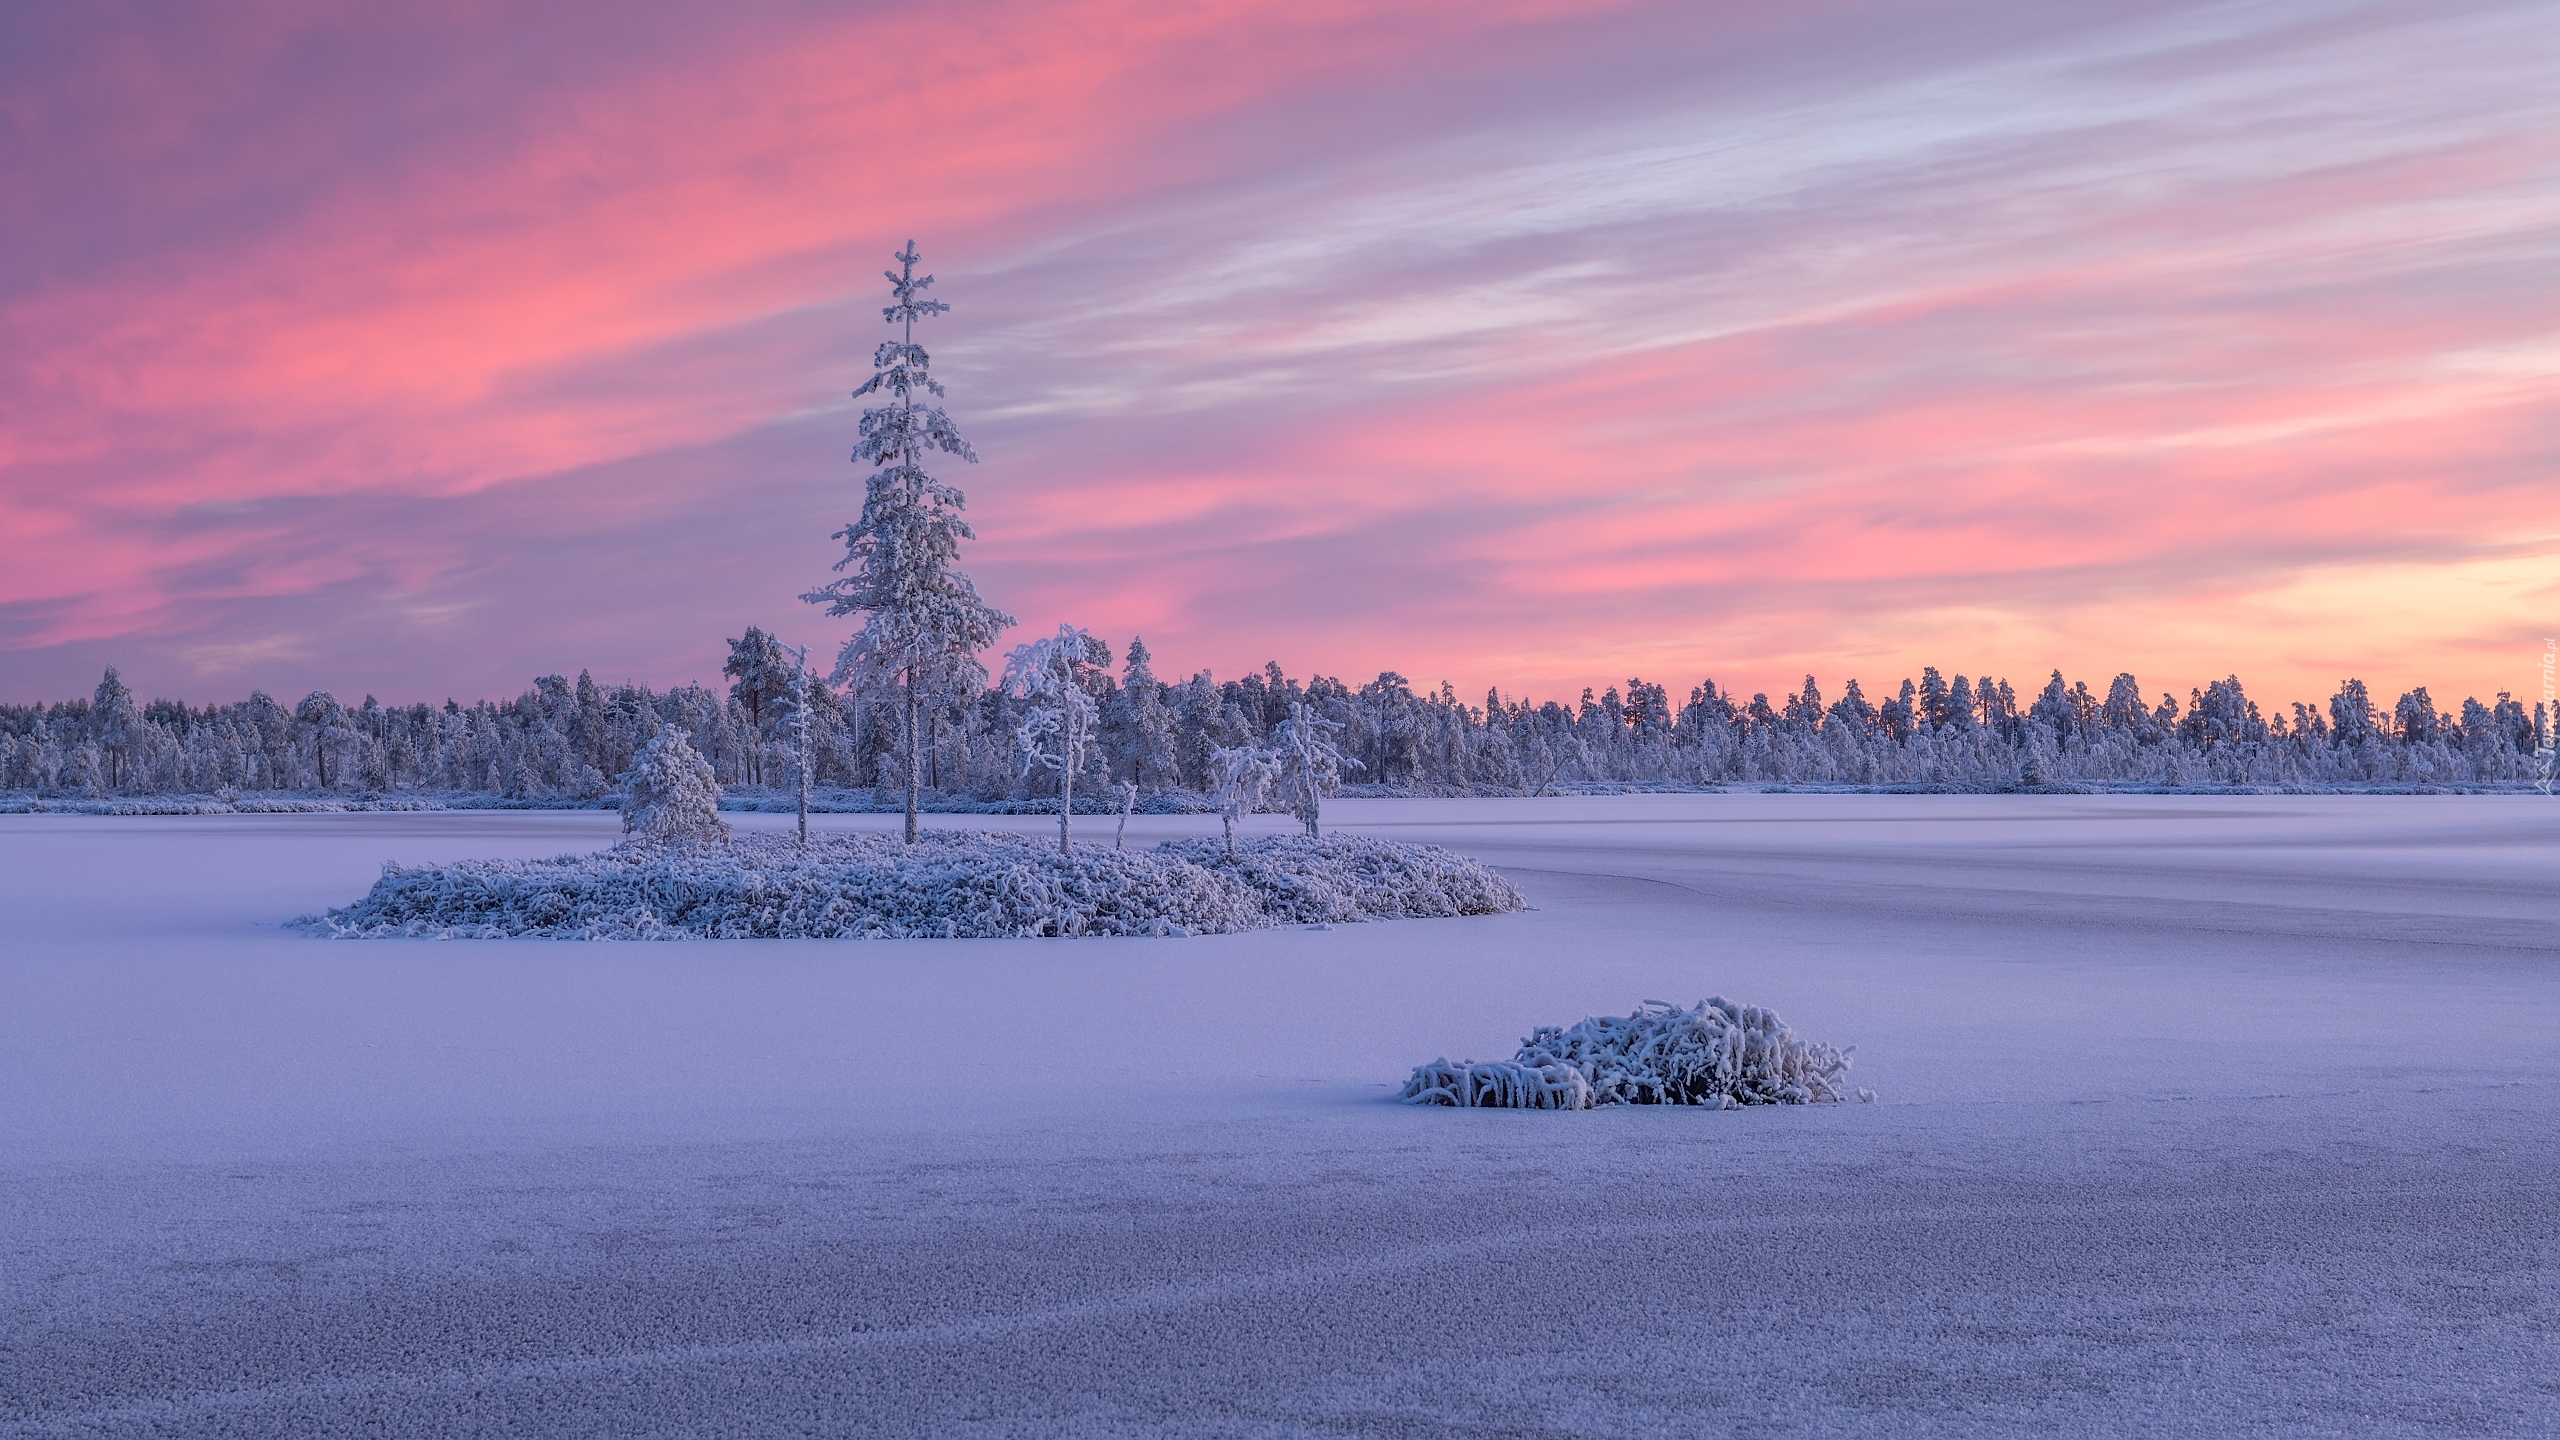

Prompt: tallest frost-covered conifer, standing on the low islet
[{"left": 801, "top": 241, "right": 1014, "bottom": 843}]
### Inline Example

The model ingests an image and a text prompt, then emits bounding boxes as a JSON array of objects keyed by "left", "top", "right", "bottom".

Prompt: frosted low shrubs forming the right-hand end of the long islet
[{"left": 1157, "top": 835, "right": 1528, "bottom": 925}]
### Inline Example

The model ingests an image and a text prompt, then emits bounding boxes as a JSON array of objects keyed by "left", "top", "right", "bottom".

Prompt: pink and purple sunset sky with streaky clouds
[{"left": 0, "top": 0, "right": 2560, "bottom": 702}]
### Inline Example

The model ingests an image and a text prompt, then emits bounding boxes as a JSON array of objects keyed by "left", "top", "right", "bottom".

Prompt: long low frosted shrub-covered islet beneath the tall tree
[{"left": 294, "top": 830, "right": 1526, "bottom": 940}]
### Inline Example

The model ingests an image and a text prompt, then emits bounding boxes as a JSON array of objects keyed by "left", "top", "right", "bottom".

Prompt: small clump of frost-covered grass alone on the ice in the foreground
[{"left": 1403, "top": 997, "right": 1876, "bottom": 1109}]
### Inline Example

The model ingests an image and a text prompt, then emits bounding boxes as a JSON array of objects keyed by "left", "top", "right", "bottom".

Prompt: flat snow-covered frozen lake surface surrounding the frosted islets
[{"left": 0, "top": 794, "right": 2560, "bottom": 1437}]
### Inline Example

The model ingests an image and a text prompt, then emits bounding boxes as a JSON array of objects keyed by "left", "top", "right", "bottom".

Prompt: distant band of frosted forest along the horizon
[{"left": 0, "top": 630, "right": 2552, "bottom": 807}]
